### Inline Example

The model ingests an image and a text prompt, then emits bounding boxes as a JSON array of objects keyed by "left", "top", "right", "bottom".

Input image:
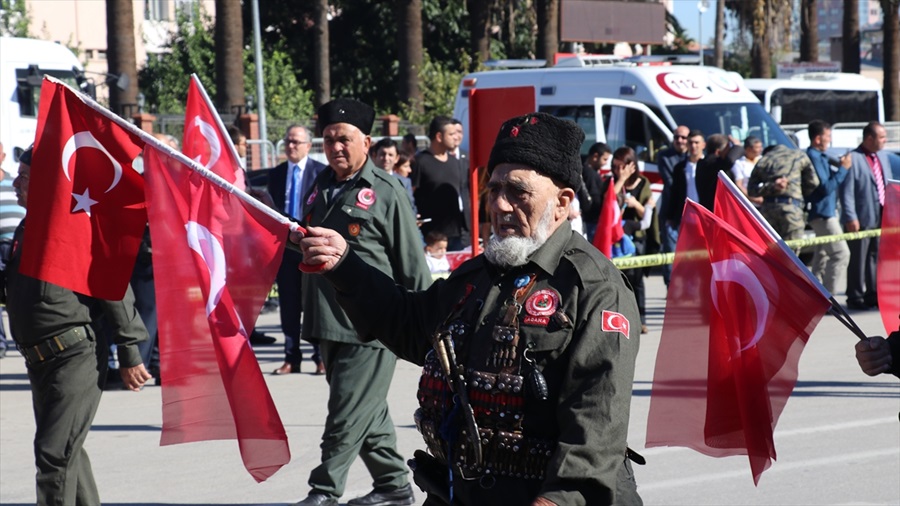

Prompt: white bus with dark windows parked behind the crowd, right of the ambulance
[{"left": 746, "top": 72, "right": 884, "bottom": 150}]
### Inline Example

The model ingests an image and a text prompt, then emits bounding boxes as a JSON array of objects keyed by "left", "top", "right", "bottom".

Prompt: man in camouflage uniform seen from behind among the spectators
[{"left": 747, "top": 145, "right": 819, "bottom": 240}]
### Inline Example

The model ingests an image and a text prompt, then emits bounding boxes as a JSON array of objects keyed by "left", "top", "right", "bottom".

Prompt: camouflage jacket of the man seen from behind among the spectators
[{"left": 747, "top": 145, "right": 819, "bottom": 201}]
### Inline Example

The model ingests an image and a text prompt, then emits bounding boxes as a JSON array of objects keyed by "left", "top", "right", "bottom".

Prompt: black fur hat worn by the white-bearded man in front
[{"left": 488, "top": 112, "right": 584, "bottom": 191}]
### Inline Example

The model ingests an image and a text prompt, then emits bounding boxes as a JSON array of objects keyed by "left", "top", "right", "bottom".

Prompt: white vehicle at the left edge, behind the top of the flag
[{"left": 0, "top": 37, "right": 84, "bottom": 176}]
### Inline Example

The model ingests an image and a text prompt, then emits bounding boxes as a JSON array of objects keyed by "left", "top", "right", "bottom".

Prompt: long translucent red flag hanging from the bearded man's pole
[{"left": 144, "top": 147, "right": 290, "bottom": 481}]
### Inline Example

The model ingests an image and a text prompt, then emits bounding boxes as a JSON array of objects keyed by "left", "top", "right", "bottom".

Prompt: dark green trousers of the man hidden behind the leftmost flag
[{"left": 28, "top": 334, "right": 106, "bottom": 506}]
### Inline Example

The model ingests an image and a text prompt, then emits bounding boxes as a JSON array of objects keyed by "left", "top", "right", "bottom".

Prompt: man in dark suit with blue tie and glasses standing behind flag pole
[{"left": 268, "top": 125, "right": 325, "bottom": 374}]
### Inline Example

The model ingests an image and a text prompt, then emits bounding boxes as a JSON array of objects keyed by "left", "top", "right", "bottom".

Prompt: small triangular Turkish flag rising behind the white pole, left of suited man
[{"left": 181, "top": 75, "right": 246, "bottom": 190}]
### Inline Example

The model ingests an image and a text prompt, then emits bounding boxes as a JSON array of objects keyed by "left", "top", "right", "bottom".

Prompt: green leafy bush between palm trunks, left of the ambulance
[{"left": 400, "top": 52, "right": 471, "bottom": 125}]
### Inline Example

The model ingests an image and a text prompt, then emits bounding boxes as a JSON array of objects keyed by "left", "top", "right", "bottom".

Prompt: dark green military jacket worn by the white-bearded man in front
[{"left": 324, "top": 222, "right": 640, "bottom": 505}]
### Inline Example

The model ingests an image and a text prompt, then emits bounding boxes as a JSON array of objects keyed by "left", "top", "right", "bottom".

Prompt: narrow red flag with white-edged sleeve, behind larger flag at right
[{"left": 713, "top": 173, "right": 831, "bottom": 298}]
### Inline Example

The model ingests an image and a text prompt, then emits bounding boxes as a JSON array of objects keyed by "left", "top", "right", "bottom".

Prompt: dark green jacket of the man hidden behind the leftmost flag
[{"left": 6, "top": 220, "right": 147, "bottom": 367}]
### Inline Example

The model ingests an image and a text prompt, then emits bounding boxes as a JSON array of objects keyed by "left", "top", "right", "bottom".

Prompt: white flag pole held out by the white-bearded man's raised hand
[{"left": 44, "top": 75, "right": 298, "bottom": 235}]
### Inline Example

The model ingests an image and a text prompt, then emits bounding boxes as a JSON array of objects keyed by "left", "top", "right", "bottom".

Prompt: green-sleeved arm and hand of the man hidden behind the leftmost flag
[{"left": 96, "top": 285, "right": 152, "bottom": 392}]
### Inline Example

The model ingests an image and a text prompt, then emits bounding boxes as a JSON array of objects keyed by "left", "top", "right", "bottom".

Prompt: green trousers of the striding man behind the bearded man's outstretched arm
[{"left": 309, "top": 341, "right": 408, "bottom": 497}]
